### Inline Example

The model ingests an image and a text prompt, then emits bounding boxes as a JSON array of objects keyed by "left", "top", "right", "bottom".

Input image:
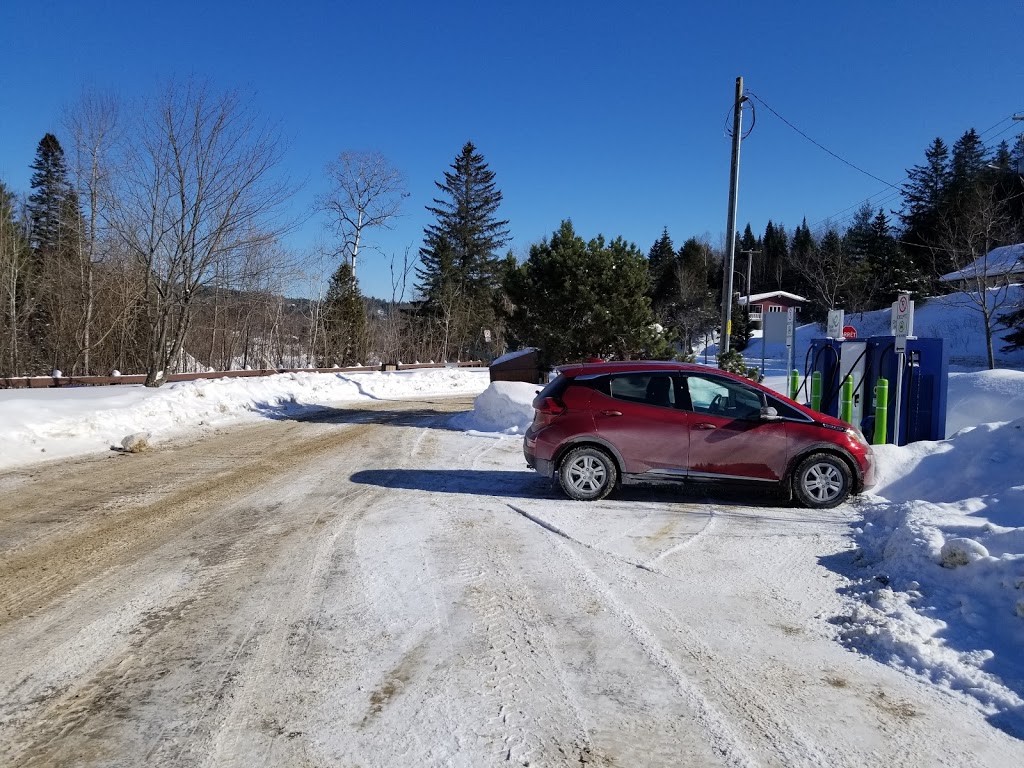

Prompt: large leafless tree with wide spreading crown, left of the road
[{"left": 111, "top": 82, "right": 291, "bottom": 386}]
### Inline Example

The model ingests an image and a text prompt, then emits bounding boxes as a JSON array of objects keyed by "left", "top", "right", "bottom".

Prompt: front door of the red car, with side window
[{"left": 684, "top": 374, "right": 790, "bottom": 481}]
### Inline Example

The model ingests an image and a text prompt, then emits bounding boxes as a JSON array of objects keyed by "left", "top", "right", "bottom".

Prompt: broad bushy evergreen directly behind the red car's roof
[{"left": 508, "top": 220, "right": 671, "bottom": 364}]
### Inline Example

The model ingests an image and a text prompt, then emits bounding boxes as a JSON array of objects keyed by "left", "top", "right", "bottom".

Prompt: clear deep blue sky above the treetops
[{"left": 0, "top": 0, "right": 1024, "bottom": 295}]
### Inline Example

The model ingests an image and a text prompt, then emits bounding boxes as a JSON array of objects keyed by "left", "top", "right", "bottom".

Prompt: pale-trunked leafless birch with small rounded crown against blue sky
[{"left": 316, "top": 152, "right": 409, "bottom": 279}]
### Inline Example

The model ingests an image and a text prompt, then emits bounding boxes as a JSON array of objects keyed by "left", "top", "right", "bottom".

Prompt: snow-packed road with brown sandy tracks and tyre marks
[{"left": 0, "top": 398, "right": 1024, "bottom": 768}]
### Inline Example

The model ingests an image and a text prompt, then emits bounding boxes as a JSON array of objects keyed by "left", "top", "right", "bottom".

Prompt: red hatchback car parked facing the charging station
[{"left": 523, "top": 361, "right": 874, "bottom": 508}]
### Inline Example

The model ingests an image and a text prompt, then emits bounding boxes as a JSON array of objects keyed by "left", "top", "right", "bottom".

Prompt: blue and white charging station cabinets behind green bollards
[{"left": 804, "top": 336, "right": 948, "bottom": 445}]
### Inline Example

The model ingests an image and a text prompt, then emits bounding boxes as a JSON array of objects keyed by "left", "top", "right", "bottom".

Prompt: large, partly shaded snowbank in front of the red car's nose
[{"left": 841, "top": 411, "right": 1024, "bottom": 737}]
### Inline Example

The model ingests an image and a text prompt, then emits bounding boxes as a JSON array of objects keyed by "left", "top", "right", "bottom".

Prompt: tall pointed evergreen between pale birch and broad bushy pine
[{"left": 416, "top": 141, "right": 511, "bottom": 356}]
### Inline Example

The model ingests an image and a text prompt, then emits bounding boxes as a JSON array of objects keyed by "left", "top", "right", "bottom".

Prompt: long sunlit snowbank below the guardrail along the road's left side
[{"left": 0, "top": 369, "right": 487, "bottom": 469}]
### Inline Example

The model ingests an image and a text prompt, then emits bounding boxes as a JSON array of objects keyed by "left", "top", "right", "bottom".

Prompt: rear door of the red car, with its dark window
[{"left": 591, "top": 371, "right": 689, "bottom": 478}]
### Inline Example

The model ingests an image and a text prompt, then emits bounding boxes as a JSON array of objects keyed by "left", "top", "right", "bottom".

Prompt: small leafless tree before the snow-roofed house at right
[{"left": 928, "top": 185, "right": 1020, "bottom": 370}]
